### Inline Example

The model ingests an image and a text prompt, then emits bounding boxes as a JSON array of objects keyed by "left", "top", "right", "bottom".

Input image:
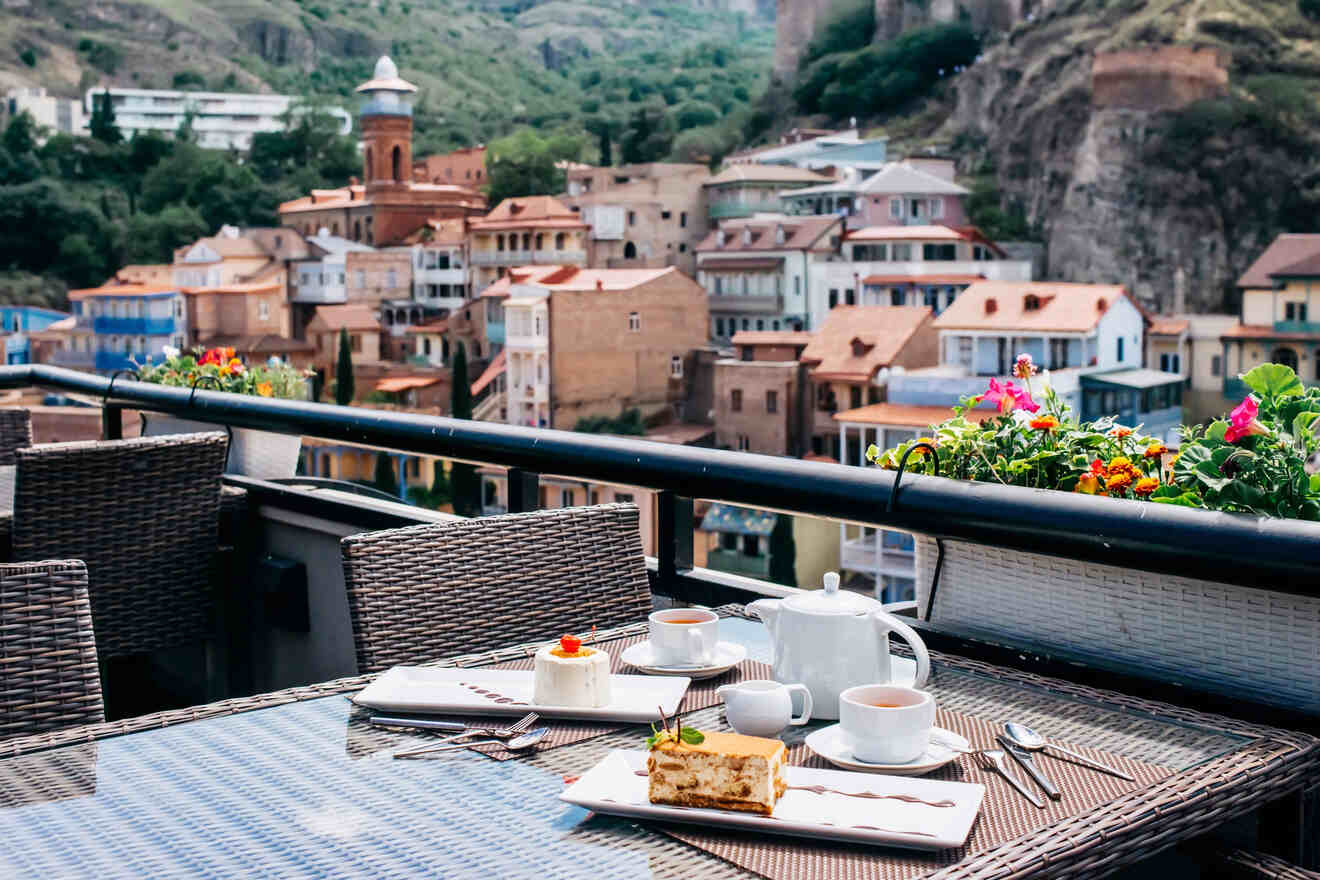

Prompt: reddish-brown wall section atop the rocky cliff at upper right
[{"left": 1090, "top": 46, "right": 1229, "bottom": 111}]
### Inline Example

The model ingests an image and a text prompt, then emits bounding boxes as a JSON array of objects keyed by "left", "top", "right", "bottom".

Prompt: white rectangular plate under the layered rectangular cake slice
[{"left": 560, "top": 749, "right": 986, "bottom": 850}]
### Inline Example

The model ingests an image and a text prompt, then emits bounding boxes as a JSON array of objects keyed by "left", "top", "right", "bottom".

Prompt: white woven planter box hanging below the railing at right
[{"left": 916, "top": 528, "right": 1320, "bottom": 712}]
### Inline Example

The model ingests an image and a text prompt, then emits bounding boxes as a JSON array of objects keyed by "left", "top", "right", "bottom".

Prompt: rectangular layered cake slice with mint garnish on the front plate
[{"left": 647, "top": 723, "right": 788, "bottom": 815}]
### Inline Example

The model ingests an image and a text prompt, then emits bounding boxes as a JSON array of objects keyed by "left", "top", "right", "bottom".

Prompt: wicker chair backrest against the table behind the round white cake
[{"left": 342, "top": 504, "right": 651, "bottom": 673}]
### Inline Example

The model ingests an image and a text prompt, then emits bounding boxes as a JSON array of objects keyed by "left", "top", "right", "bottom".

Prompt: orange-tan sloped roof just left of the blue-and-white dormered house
[{"left": 801, "top": 306, "right": 932, "bottom": 381}]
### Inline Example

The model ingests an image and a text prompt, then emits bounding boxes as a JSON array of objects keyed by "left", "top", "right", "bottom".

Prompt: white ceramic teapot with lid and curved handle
[{"left": 747, "top": 571, "right": 931, "bottom": 719}]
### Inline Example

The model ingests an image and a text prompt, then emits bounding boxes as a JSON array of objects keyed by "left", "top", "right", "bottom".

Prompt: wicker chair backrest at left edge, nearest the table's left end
[{"left": 0, "top": 559, "right": 106, "bottom": 740}]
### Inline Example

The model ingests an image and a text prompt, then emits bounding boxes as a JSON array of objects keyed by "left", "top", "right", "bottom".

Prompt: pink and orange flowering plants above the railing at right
[{"left": 866, "top": 355, "right": 1320, "bottom": 520}]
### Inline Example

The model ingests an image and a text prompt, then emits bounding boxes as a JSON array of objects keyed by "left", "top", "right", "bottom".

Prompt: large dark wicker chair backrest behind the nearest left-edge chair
[{"left": 13, "top": 433, "right": 228, "bottom": 660}]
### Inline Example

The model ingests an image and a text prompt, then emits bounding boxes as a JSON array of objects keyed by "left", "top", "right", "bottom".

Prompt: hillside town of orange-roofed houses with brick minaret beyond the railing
[{"left": 3, "top": 57, "right": 1320, "bottom": 606}]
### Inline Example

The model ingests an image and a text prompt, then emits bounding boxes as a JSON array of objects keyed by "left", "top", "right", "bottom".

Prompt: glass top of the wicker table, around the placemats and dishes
[{"left": 0, "top": 619, "right": 1245, "bottom": 879}]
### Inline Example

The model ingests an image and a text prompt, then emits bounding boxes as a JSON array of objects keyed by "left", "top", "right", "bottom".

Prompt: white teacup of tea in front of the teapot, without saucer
[{"left": 838, "top": 685, "right": 935, "bottom": 764}]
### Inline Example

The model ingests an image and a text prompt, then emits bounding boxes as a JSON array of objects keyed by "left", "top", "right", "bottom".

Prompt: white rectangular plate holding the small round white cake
[{"left": 352, "top": 666, "right": 692, "bottom": 724}]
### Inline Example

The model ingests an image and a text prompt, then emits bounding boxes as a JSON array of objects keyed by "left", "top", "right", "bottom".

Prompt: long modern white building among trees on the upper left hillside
[{"left": 82, "top": 87, "right": 352, "bottom": 150}]
